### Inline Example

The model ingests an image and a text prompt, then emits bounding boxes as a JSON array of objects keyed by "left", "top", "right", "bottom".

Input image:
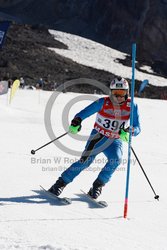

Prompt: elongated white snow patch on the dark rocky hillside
[{"left": 49, "top": 30, "right": 167, "bottom": 86}]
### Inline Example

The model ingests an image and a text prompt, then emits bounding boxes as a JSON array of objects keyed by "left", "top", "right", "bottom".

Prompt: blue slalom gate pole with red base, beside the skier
[{"left": 124, "top": 43, "right": 136, "bottom": 218}]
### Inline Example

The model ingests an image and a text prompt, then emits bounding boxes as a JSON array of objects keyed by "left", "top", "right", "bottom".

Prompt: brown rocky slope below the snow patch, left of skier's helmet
[{"left": 0, "top": 24, "right": 116, "bottom": 92}]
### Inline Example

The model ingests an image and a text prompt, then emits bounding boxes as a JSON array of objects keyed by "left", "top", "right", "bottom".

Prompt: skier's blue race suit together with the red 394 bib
[{"left": 61, "top": 97, "right": 141, "bottom": 184}]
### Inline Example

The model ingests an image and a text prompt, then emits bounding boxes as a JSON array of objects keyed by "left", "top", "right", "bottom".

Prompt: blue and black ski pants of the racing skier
[{"left": 61, "top": 129, "right": 123, "bottom": 184}]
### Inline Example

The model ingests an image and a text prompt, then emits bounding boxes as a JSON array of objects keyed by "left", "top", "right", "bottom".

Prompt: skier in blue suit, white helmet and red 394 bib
[{"left": 48, "top": 77, "right": 140, "bottom": 199}]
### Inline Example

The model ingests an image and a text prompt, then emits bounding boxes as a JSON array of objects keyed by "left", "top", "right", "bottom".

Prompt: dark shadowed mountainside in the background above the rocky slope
[{"left": 0, "top": 0, "right": 167, "bottom": 76}]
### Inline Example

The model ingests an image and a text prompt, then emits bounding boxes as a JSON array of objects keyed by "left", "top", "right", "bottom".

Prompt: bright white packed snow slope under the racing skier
[{"left": 0, "top": 90, "right": 167, "bottom": 250}]
